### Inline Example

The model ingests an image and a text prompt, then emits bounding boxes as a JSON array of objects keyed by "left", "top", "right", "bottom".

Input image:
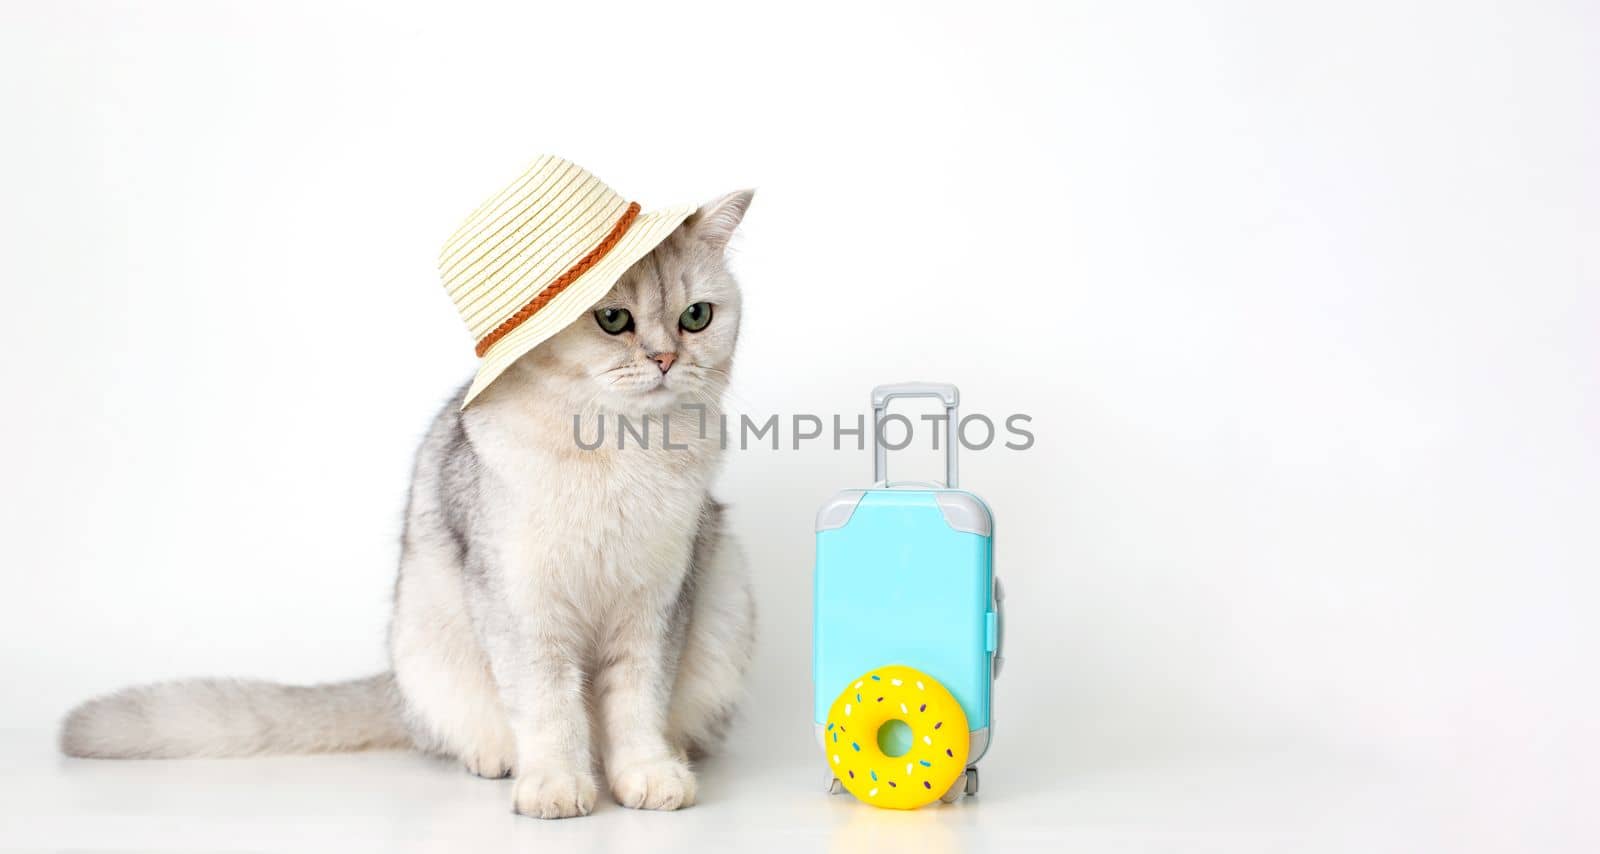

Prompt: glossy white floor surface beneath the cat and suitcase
[{"left": 0, "top": 731, "right": 1579, "bottom": 854}]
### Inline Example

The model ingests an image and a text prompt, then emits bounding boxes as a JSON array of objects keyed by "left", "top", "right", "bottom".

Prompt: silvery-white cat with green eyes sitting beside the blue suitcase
[{"left": 61, "top": 190, "right": 755, "bottom": 819}]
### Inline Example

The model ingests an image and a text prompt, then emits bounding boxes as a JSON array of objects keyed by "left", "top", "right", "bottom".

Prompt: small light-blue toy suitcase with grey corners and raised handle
[{"left": 811, "top": 382, "right": 1003, "bottom": 801}]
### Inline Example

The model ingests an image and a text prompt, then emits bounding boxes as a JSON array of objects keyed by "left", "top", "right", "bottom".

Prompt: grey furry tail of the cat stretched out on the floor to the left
[{"left": 61, "top": 673, "right": 413, "bottom": 760}]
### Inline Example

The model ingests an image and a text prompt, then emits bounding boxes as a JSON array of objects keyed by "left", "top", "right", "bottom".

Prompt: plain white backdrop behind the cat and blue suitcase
[{"left": 0, "top": 2, "right": 1600, "bottom": 851}]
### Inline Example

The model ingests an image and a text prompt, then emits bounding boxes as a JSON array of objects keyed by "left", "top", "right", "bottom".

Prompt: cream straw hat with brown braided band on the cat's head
[{"left": 438, "top": 155, "right": 696, "bottom": 409}]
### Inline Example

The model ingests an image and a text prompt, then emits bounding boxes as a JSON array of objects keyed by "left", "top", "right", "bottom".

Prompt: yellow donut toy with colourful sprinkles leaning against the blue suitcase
[{"left": 822, "top": 665, "right": 968, "bottom": 809}]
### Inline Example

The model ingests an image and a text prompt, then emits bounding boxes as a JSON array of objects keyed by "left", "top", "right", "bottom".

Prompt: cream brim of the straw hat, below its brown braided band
[{"left": 461, "top": 205, "right": 696, "bottom": 409}]
